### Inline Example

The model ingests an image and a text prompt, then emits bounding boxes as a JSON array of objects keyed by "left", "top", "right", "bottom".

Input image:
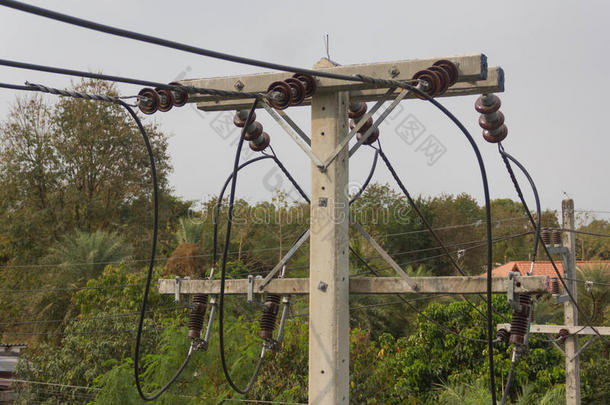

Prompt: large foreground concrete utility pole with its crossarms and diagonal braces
[{"left": 159, "top": 54, "right": 548, "bottom": 405}]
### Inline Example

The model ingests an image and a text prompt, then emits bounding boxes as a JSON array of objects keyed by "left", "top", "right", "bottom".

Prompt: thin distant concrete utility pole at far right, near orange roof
[{"left": 561, "top": 199, "right": 580, "bottom": 405}]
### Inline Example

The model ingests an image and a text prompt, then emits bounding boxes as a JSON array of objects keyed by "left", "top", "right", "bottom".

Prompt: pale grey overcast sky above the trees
[{"left": 0, "top": 0, "right": 610, "bottom": 221}]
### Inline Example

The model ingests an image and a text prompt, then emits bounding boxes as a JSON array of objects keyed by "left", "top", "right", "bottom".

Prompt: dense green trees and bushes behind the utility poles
[{"left": 0, "top": 82, "right": 610, "bottom": 405}]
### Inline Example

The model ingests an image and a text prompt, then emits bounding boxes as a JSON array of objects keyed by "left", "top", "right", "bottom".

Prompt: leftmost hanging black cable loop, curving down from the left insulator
[{"left": 119, "top": 101, "right": 191, "bottom": 401}]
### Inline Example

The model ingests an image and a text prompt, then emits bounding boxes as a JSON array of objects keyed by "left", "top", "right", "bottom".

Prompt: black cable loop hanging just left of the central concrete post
[{"left": 214, "top": 98, "right": 263, "bottom": 394}]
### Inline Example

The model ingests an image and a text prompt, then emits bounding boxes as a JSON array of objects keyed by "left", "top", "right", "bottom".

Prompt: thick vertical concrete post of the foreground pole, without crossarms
[{"left": 309, "top": 58, "right": 349, "bottom": 404}]
